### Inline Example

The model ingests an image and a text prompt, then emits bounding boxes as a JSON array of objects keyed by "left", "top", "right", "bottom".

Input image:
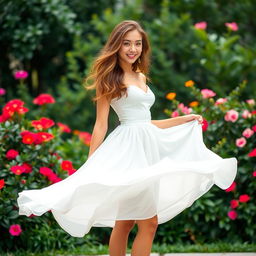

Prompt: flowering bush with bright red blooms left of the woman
[{"left": 0, "top": 71, "right": 97, "bottom": 251}]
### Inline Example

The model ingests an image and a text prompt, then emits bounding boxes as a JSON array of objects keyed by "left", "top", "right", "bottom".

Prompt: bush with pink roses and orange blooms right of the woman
[{"left": 153, "top": 80, "right": 256, "bottom": 244}]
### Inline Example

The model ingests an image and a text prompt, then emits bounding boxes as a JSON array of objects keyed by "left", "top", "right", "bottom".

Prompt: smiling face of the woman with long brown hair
[{"left": 118, "top": 30, "right": 142, "bottom": 64}]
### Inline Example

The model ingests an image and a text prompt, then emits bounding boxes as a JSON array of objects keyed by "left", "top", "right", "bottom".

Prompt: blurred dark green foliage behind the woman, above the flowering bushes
[{"left": 0, "top": 0, "right": 256, "bottom": 132}]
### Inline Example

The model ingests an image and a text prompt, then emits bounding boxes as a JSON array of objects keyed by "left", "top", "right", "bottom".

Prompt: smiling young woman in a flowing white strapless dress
[{"left": 18, "top": 20, "right": 237, "bottom": 256}]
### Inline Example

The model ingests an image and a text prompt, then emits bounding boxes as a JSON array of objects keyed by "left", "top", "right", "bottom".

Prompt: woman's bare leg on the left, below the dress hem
[{"left": 109, "top": 220, "right": 135, "bottom": 256}]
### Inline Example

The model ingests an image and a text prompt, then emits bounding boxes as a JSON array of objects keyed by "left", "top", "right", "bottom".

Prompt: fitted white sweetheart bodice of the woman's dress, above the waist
[{"left": 110, "top": 85, "right": 155, "bottom": 124}]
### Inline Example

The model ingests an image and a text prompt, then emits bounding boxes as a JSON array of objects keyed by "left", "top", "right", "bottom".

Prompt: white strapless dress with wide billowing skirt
[{"left": 17, "top": 85, "right": 237, "bottom": 237}]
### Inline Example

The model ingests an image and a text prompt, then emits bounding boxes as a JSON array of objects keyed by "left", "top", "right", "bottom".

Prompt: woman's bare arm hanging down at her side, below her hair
[{"left": 88, "top": 91, "right": 110, "bottom": 158}]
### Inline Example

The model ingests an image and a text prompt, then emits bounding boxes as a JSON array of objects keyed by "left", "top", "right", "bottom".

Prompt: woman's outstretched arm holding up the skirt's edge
[{"left": 151, "top": 114, "right": 203, "bottom": 129}]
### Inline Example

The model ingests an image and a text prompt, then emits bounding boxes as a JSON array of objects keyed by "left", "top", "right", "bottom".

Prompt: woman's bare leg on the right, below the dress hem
[{"left": 131, "top": 215, "right": 158, "bottom": 256}]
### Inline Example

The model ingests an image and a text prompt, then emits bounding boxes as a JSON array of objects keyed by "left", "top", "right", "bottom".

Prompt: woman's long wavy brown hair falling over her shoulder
[{"left": 84, "top": 20, "right": 151, "bottom": 101}]
